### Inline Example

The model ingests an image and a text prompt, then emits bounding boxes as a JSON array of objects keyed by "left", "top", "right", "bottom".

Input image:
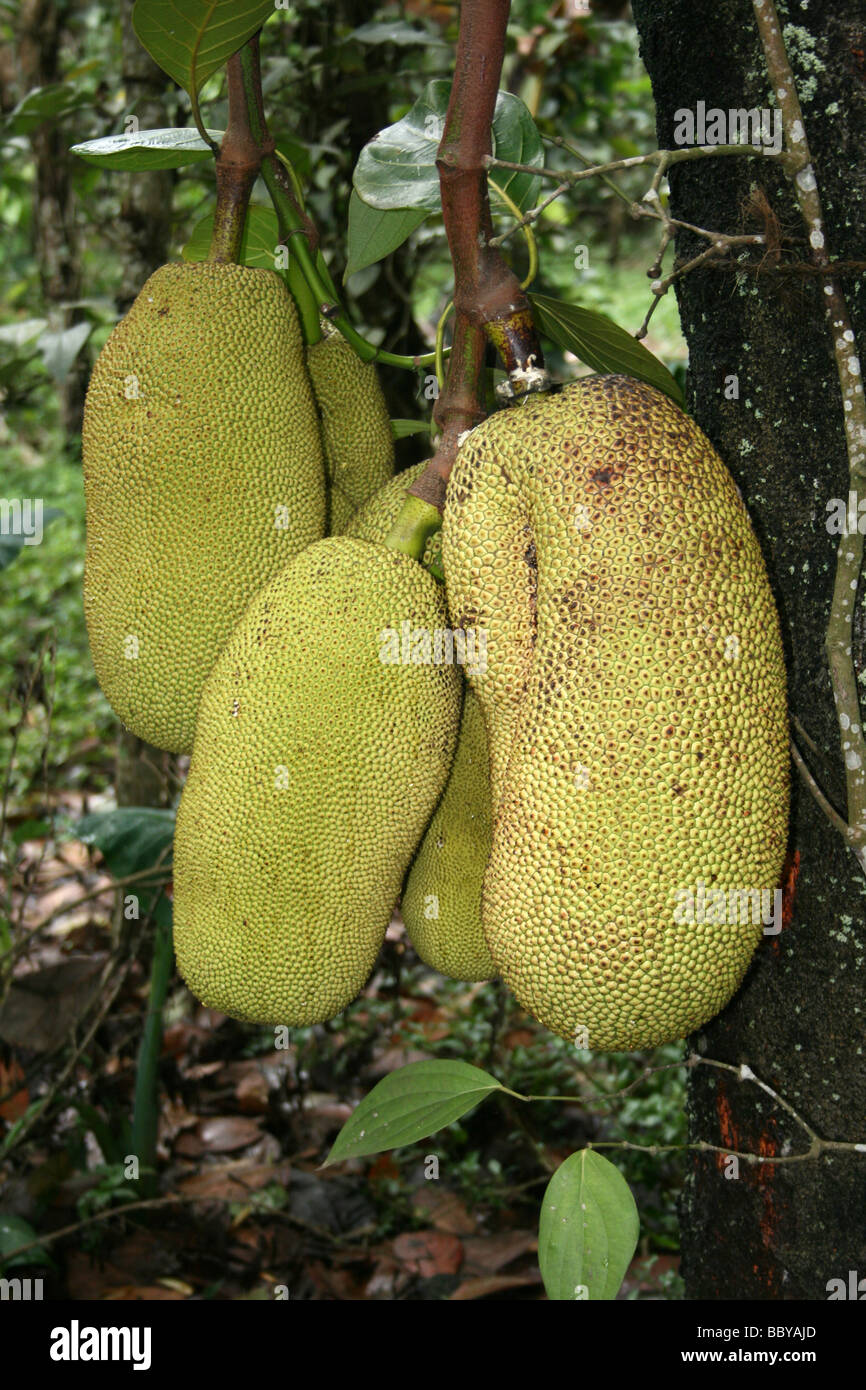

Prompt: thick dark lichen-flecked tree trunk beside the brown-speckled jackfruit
[{"left": 632, "top": 0, "right": 866, "bottom": 1300}]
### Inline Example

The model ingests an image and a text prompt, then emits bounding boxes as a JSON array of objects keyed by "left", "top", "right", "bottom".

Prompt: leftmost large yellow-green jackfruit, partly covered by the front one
[{"left": 83, "top": 261, "right": 325, "bottom": 753}]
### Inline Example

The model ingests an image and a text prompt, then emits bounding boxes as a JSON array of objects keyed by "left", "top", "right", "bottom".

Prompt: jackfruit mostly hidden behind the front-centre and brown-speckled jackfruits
[{"left": 346, "top": 461, "right": 496, "bottom": 980}]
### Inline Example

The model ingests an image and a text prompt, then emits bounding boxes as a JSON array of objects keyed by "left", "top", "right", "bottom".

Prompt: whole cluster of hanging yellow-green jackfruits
[{"left": 83, "top": 263, "right": 788, "bottom": 1048}]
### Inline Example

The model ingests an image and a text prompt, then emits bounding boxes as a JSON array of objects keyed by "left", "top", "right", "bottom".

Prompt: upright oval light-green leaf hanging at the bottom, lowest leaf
[{"left": 538, "top": 1148, "right": 641, "bottom": 1301}]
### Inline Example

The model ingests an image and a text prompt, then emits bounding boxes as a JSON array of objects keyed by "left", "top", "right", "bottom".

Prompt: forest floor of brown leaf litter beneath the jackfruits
[{"left": 0, "top": 794, "right": 683, "bottom": 1301}]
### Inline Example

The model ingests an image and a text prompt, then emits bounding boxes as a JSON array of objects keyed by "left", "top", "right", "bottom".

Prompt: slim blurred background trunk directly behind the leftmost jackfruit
[{"left": 114, "top": 0, "right": 177, "bottom": 806}]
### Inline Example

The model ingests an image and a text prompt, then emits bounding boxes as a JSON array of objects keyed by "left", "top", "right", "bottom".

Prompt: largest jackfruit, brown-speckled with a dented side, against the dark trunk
[{"left": 442, "top": 377, "right": 788, "bottom": 1049}]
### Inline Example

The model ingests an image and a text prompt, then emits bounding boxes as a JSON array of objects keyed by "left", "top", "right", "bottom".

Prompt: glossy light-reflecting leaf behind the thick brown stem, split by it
[{"left": 354, "top": 78, "right": 544, "bottom": 211}]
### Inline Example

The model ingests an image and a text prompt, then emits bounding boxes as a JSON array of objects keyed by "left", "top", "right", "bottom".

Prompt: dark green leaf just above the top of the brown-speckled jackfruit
[{"left": 530, "top": 295, "right": 683, "bottom": 407}]
